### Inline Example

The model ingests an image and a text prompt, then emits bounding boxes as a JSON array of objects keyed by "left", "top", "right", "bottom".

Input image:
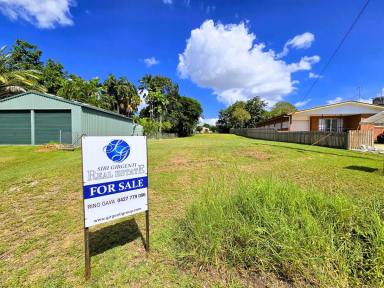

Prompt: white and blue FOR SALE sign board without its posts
[{"left": 82, "top": 136, "right": 148, "bottom": 227}]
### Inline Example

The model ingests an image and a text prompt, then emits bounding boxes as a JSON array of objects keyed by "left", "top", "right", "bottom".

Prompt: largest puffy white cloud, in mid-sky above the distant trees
[{"left": 177, "top": 20, "right": 320, "bottom": 104}]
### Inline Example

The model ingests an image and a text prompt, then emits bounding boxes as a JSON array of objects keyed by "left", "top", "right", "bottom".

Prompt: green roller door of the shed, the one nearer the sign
[{"left": 35, "top": 110, "right": 72, "bottom": 144}]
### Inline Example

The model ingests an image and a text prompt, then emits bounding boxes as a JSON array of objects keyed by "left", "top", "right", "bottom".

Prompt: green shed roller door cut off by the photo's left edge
[{"left": 0, "top": 110, "right": 31, "bottom": 144}]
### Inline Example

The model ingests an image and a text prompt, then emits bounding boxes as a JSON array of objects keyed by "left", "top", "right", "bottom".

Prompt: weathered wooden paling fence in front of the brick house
[{"left": 231, "top": 128, "right": 373, "bottom": 149}]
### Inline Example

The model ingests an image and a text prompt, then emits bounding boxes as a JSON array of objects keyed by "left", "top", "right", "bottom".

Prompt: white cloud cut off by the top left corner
[{"left": 0, "top": 0, "right": 75, "bottom": 28}]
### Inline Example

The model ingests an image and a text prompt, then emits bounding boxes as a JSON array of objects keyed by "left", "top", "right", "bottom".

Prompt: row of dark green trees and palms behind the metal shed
[{"left": 0, "top": 39, "right": 202, "bottom": 136}]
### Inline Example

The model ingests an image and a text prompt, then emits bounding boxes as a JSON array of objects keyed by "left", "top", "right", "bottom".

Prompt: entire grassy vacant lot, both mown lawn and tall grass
[{"left": 0, "top": 135, "right": 384, "bottom": 287}]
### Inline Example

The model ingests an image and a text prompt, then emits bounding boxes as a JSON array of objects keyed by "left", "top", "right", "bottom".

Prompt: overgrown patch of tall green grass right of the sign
[{"left": 174, "top": 179, "right": 384, "bottom": 287}]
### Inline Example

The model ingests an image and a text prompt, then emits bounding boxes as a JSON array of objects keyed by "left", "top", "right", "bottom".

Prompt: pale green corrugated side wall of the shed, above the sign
[{"left": 81, "top": 107, "right": 142, "bottom": 136}]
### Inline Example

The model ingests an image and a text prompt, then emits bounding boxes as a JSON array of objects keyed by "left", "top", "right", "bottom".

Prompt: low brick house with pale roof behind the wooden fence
[{"left": 256, "top": 101, "right": 384, "bottom": 132}]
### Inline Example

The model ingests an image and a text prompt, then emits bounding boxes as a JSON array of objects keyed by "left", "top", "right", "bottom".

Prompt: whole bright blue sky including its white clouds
[{"left": 0, "top": 0, "right": 384, "bottom": 123}]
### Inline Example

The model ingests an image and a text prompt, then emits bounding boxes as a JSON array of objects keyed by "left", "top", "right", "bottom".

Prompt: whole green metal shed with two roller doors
[{"left": 0, "top": 91, "right": 143, "bottom": 145}]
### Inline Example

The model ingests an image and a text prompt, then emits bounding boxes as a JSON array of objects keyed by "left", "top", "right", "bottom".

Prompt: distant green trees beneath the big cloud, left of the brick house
[{"left": 216, "top": 96, "right": 296, "bottom": 133}]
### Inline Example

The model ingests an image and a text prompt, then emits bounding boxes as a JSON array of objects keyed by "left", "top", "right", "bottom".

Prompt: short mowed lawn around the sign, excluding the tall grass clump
[{"left": 0, "top": 135, "right": 384, "bottom": 287}]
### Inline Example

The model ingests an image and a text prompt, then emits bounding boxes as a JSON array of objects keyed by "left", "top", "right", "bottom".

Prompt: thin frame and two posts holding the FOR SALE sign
[{"left": 81, "top": 135, "right": 150, "bottom": 280}]
